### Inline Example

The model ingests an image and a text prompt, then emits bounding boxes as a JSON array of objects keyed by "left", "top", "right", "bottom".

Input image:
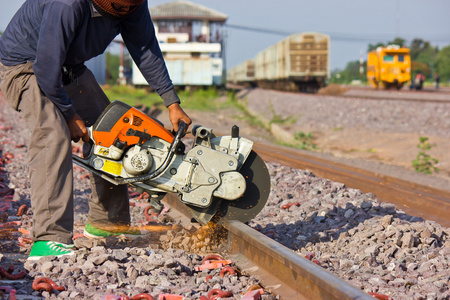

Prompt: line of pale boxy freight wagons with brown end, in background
[{"left": 227, "top": 32, "right": 330, "bottom": 92}]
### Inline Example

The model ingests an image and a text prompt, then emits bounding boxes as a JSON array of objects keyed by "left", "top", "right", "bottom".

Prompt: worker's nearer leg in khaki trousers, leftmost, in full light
[{"left": 1, "top": 63, "right": 73, "bottom": 244}]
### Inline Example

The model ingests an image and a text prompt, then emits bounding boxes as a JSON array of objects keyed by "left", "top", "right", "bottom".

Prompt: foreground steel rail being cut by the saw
[{"left": 163, "top": 194, "right": 374, "bottom": 300}]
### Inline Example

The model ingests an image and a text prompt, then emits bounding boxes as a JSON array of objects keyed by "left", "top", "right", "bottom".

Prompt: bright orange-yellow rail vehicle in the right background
[{"left": 367, "top": 45, "right": 411, "bottom": 89}]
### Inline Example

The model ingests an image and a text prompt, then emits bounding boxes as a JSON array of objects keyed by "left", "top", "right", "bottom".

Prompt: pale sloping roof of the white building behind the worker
[{"left": 150, "top": 0, "right": 228, "bottom": 22}]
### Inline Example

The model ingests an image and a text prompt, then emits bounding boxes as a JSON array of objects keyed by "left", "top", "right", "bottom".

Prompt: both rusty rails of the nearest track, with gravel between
[{"left": 163, "top": 144, "right": 450, "bottom": 299}]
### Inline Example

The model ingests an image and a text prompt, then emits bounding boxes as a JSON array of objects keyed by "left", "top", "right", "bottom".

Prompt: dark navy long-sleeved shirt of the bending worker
[{"left": 0, "top": 0, "right": 179, "bottom": 120}]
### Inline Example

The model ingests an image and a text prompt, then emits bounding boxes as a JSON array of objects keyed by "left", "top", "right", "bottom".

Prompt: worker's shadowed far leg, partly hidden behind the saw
[{"left": 65, "top": 70, "right": 130, "bottom": 230}]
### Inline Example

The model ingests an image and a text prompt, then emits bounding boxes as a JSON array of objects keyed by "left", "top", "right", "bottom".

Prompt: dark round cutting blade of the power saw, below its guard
[{"left": 188, "top": 151, "right": 270, "bottom": 225}]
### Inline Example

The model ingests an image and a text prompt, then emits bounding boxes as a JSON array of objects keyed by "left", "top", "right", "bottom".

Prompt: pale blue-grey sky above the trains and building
[{"left": 0, "top": 0, "right": 450, "bottom": 70}]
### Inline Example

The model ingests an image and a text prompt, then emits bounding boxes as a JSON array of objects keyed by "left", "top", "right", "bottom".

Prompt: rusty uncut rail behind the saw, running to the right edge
[{"left": 253, "top": 143, "right": 450, "bottom": 227}]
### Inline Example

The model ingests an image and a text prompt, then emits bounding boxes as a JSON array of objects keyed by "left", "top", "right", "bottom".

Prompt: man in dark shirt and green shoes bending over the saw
[{"left": 0, "top": 0, "right": 191, "bottom": 260}]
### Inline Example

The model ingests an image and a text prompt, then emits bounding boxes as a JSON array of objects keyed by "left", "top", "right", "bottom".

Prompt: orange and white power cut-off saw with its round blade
[{"left": 73, "top": 101, "right": 270, "bottom": 225}]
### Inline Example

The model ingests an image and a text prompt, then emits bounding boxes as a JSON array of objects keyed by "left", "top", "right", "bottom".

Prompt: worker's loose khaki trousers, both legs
[{"left": 0, "top": 62, "right": 130, "bottom": 244}]
